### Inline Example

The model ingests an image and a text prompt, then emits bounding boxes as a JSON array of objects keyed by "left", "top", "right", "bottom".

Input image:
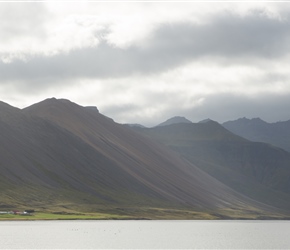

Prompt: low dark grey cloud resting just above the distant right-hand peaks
[{"left": 183, "top": 93, "right": 290, "bottom": 122}]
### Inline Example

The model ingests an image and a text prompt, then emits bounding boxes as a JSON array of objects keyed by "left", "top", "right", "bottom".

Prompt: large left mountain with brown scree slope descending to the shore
[{"left": 0, "top": 98, "right": 280, "bottom": 218}]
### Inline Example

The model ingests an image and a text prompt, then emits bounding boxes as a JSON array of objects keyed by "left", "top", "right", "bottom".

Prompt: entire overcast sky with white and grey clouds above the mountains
[{"left": 0, "top": 1, "right": 290, "bottom": 127}]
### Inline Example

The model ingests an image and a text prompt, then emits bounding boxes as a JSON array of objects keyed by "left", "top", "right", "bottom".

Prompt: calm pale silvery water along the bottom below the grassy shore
[{"left": 0, "top": 221, "right": 290, "bottom": 249}]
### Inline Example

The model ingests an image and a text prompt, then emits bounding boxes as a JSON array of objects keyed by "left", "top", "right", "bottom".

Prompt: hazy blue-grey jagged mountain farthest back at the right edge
[{"left": 222, "top": 118, "right": 290, "bottom": 152}]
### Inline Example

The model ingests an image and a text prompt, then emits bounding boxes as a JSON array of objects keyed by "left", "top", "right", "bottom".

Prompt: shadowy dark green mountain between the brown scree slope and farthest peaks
[{"left": 136, "top": 121, "right": 290, "bottom": 211}]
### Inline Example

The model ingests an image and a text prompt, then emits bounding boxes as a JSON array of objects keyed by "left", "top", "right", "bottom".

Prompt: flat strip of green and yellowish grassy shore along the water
[{"left": 0, "top": 207, "right": 290, "bottom": 221}]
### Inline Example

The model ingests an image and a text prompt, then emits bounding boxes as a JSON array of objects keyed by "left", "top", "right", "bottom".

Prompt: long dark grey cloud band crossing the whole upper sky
[{"left": 0, "top": 8, "right": 290, "bottom": 87}]
